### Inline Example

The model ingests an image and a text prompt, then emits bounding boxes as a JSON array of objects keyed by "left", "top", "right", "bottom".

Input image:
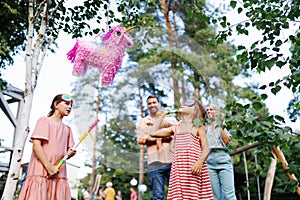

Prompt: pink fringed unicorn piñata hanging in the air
[{"left": 67, "top": 26, "right": 133, "bottom": 85}]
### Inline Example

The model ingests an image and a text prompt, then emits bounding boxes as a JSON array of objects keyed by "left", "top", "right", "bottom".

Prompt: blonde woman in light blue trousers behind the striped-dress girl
[{"left": 206, "top": 104, "right": 236, "bottom": 200}]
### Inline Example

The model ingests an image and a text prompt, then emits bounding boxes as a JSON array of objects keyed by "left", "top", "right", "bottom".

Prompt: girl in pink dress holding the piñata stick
[{"left": 19, "top": 94, "right": 76, "bottom": 200}]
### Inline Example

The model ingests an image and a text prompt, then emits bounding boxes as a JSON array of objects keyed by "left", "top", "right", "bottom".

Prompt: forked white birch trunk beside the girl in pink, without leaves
[{"left": 1, "top": 0, "right": 48, "bottom": 200}]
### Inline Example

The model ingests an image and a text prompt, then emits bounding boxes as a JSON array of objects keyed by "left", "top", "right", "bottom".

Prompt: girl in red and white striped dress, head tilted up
[{"left": 151, "top": 98, "right": 213, "bottom": 200}]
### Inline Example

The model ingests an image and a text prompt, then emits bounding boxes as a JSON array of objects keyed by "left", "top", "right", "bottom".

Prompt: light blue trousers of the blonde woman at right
[{"left": 206, "top": 151, "right": 236, "bottom": 200}]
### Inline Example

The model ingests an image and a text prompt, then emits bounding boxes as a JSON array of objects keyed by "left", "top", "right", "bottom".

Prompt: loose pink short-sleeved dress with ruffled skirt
[{"left": 19, "top": 117, "right": 74, "bottom": 200}]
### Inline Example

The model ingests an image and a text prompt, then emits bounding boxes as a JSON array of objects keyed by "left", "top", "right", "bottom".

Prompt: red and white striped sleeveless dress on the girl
[{"left": 167, "top": 129, "right": 214, "bottom": 200}]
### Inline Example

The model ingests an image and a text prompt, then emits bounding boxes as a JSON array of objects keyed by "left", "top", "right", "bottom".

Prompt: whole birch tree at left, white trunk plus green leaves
[{"left": 1, "top": 0, "right": 113, "bottom": 197}]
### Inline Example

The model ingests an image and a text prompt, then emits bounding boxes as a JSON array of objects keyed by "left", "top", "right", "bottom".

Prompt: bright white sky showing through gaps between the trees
[{"left": 0, "top": 0, "right": 300, "bottom": 182}]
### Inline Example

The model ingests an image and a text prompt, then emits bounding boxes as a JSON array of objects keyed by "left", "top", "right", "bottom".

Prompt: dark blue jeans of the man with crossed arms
[{"left": 149, "top": 163, "right": 172, "bottom": 200}]
